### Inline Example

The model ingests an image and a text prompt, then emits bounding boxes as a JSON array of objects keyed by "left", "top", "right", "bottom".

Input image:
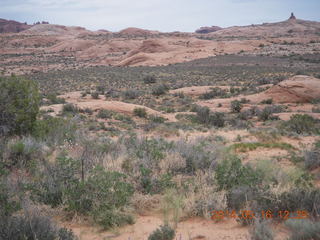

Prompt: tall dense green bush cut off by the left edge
[{"left": 0, "top": 76, "right": 40, "bottom": 135}]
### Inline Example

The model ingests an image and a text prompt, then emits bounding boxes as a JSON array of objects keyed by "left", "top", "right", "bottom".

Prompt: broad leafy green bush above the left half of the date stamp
[{"left": 215, "top": 156, "right": 262, "bottom": 190}]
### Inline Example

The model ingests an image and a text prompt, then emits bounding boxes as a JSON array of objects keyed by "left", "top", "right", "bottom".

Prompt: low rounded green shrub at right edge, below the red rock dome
[{"left": 282, "top": 114, "right": 319, "bottom": 134}]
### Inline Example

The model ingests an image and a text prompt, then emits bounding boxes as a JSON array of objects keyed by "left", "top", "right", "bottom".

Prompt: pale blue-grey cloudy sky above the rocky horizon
[{"left": 0, "top": 0, "right": 320, "bottom": 32}]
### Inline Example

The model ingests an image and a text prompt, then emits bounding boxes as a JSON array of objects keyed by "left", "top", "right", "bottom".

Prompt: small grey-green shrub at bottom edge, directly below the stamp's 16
[{"left": 250, "top": 220, "right": 274, "bottom": 240}]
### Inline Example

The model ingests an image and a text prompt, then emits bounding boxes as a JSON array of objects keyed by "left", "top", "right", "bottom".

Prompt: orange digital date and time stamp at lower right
[{"left": 211, "top": 210, "right": 309, "bottom": 220}]
